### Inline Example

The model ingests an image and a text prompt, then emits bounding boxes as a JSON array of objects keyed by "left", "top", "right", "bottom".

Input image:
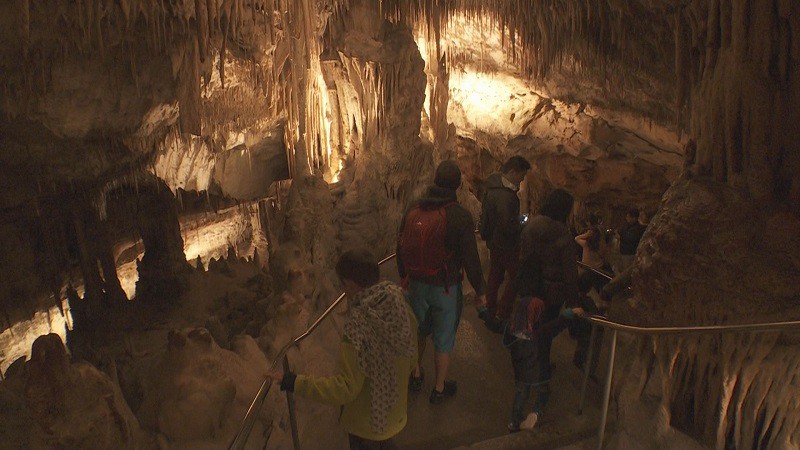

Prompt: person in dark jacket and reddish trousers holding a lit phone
[{"left": 480, "top": 156, "right": 531, "bottom": 329}]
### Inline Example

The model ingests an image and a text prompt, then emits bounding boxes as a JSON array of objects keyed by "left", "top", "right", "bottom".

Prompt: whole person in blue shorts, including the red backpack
[{"left": 397, "top": 160, "right": 486, "bottom": 404}]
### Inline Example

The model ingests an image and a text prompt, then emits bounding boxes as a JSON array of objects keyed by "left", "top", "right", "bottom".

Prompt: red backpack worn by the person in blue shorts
[{"left": 400, "top": 202, "right": 455, "bottom": 279}]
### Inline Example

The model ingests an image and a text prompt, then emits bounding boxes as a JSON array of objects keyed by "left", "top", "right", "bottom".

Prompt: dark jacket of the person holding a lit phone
[{"left": 480, "top": 172, "right": 522, "bottom": 251}]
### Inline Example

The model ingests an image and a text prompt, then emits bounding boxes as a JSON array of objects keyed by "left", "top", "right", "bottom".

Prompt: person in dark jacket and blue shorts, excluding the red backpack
[{"left": 397, "top": 160, "right": 486, "bottom": 403}]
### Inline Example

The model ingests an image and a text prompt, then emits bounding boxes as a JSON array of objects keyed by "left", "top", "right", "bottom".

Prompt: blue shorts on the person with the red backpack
[{"left": 406, "top": 280, "right": 464, "bottom": 353}]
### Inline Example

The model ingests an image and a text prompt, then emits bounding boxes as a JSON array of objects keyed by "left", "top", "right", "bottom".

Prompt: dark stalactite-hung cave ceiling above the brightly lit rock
[{"left": 0, "top": 0, "right": 675, "bottom": 193}]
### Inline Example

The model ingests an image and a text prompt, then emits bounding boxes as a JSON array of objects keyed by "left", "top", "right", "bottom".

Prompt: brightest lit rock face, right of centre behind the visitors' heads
[{"left": 416, "top": 14, "right": 685, "bottom": 227}]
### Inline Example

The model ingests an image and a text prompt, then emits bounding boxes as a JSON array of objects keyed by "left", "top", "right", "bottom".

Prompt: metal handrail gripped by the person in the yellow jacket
[{"left": 228, "top": 253, "right": 397, "bottom": 450}]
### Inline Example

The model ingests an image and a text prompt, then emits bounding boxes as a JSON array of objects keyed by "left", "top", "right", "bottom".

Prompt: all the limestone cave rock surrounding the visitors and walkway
[{"left": 0, "top": 0, "right": 800, "bottom": 448}]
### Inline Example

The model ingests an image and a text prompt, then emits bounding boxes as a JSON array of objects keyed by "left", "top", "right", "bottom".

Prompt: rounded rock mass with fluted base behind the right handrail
[{"left": 615, "top": 177, "right": 800, "bottom": 448}]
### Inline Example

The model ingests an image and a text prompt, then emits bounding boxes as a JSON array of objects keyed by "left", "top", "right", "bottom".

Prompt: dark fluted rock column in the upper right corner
[{"left": 675, "top": 0, "right": 800, "bottom": 215}]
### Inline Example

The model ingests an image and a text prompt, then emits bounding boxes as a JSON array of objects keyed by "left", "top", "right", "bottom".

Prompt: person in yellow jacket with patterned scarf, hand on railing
[{"left": 269, "top": 249, "right": 417, "bottom": 450}]
